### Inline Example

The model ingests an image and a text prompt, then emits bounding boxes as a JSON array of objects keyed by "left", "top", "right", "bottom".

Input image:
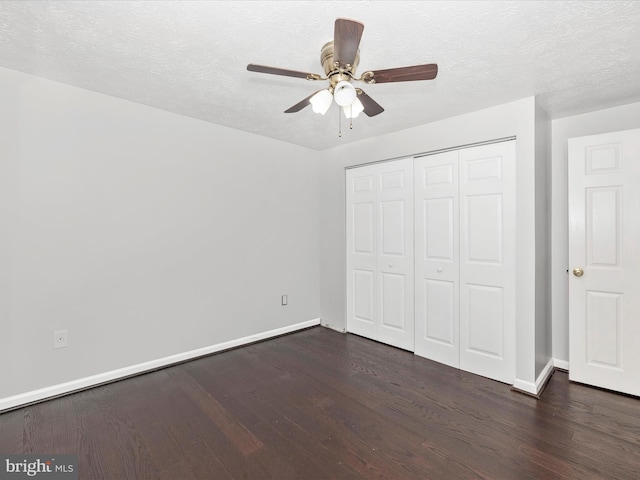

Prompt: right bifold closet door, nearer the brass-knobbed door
[{"left": 414, "top": 141, "right": 516, "bottom": 383}]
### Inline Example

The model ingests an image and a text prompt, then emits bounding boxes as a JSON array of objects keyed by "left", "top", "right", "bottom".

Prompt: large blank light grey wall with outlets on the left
[{"left": 0, "top": 69, "right": 320, "bottom": 400}]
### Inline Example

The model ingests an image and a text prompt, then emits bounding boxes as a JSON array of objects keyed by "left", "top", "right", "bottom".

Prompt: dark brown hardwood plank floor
[{"left": 0, "top": 327, "right": 640, "bottom": 480}]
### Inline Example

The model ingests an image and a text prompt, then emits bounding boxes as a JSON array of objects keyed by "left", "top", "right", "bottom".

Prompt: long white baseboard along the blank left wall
[{"left": 0, "top": 318, "right": 320, "bottom": 413}]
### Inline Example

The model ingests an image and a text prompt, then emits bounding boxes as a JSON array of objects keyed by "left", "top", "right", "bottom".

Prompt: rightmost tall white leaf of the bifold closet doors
[{"left": 459, "top": 142, "right": 516, "bottom": 383}]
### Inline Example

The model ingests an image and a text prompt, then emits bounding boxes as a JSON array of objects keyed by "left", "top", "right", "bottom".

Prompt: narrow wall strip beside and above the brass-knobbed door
[{"left": 551, "top": 103, "right": 640, "bottom": 368}]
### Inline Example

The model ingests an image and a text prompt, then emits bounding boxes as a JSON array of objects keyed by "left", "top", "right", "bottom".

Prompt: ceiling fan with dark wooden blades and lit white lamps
[{"left": 247, "top": 18, "right": 438, "bottom": 118}]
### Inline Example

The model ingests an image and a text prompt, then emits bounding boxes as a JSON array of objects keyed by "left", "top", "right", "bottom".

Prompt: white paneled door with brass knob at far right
[{"left": 569, "top": 129, "right": 640, "bottom": 395}]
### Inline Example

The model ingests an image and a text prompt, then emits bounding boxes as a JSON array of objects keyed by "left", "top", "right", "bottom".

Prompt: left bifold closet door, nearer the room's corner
[{"left": 346, "top": 158, "right": 414, "bottom": 351}]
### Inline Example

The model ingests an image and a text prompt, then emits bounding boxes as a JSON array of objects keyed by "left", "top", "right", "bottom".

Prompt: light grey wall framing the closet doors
[{"left": 320, "top": 97, "right": 536, "bottom": 384}]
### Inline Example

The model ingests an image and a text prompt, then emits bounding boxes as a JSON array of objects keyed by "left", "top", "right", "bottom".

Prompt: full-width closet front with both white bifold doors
[{"left": 347, "top": 141, "right": 516, "bottom": 383}]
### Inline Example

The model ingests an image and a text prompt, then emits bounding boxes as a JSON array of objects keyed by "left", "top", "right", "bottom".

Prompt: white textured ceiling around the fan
[{"left": 0, "top": 0, "right": 640, "bottom": 149}]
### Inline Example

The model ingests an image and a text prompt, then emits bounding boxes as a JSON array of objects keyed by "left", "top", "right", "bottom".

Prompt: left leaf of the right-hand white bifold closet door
[{"left": 414, "top": 151, "right": 459, "bottom": 368}]
